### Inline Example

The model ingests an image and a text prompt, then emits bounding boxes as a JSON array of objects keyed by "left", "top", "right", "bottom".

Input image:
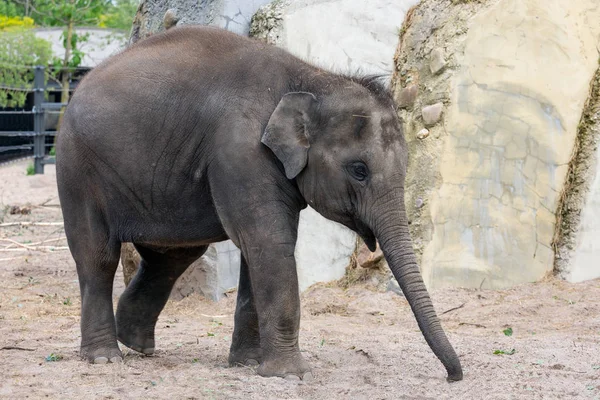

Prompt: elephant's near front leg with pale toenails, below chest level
[{"left": 236, "top": 228, "right": 312, "bottom": 380}]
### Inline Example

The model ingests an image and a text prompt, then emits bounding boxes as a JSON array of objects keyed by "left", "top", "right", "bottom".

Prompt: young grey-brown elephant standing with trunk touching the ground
[{"left": 56, "top": 26, "right": 463, "bottom": 381}]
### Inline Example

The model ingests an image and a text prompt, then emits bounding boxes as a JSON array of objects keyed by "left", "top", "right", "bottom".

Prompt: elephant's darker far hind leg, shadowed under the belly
[{"left": 117, "top": 245, "right": 208, "bottom": 354}]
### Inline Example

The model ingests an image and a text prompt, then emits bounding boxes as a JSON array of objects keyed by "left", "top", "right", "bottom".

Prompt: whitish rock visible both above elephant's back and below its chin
[{"left": 250, "top": 0, "right": 418, "bottom": 290}]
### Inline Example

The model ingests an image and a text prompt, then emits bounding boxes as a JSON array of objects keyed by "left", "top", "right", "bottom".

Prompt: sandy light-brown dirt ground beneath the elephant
[{"left": 0, "top": 162, "right": 600, "bottom": 399}]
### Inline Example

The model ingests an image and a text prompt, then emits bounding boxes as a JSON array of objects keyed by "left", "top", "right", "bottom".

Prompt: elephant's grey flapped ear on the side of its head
[{"left": 260, "top": 92, "right": 317, "bottom": 179}]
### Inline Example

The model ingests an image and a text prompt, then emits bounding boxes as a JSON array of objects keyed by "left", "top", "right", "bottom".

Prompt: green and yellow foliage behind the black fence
[{"left": 0, "top": 0, "right": 139, "bottom": 107}]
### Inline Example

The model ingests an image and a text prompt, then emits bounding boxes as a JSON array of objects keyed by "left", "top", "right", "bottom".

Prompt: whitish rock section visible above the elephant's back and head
[{"left": 251, "top": 0, "right": 418, "bottom": 74}]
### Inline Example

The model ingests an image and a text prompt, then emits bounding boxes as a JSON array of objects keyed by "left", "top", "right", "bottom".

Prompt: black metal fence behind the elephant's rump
[{"left": 0, "top": 66, "right": 66, "bottom": 174}]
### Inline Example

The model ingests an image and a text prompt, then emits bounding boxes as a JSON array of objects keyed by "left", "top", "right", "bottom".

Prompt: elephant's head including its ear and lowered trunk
[{"left": 262, "top": 79, "right": 463, "bottom": 381}]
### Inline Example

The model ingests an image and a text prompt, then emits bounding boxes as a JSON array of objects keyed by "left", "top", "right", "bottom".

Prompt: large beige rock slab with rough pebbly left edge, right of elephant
[{"left": 394, "top": 0, "right": 600, "bottom": 288}]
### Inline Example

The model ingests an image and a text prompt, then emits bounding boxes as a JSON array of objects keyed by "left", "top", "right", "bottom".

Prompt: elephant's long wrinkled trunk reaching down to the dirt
[{"left": 373, "top": 200, "right": 463, "bottom": 381}]
